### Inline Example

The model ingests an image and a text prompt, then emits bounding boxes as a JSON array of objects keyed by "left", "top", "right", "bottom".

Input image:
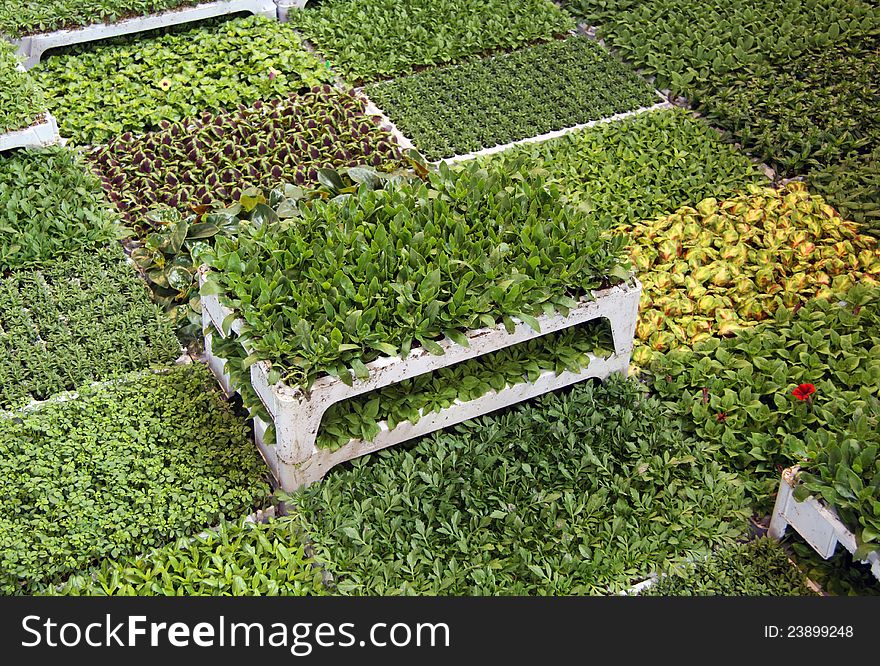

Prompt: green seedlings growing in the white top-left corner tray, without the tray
[{"left": 0, "top": 0, "right": 205, "bottom": 37}]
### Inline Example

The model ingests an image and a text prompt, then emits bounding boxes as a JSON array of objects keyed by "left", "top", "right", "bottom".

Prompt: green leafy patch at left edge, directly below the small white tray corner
[{"left": 0, "top": 148, "right": 119, "bottom": 276}]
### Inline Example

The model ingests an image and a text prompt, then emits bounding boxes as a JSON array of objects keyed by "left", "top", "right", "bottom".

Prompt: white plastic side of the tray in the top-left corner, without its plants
[{"left": 13, "top": 0, "right": 278, "bottom": 69}]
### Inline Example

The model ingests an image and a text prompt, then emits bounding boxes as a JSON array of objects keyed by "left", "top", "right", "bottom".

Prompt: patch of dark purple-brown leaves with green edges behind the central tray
[{"left": 90, "top": 85, "right": 404, "bottom": 222}]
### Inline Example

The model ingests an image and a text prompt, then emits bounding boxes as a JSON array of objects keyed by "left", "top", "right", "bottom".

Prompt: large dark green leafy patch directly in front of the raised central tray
[{"left": 294, "top": 370, "right": 746, "bottom": 595}]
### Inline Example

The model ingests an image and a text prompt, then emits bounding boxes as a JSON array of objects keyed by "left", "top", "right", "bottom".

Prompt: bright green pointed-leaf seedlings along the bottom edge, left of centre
[{"left": 58, "top": 518, "right": 324, "bottom": 597}]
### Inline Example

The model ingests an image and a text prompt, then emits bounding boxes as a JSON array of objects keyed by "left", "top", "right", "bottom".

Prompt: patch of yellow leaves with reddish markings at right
[{"left": 623, "top": 182, "right": 880, "bottom": 363}]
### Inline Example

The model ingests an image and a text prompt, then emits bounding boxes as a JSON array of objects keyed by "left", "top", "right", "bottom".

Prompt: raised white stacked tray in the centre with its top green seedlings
[{"left": 201, "top": 158, "right": 641, "bottom": 488}]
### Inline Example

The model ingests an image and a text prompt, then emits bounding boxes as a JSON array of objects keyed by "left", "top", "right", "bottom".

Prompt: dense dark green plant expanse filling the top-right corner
[{"left": 568, "top": 0, "right": 880, "bottom": 233}]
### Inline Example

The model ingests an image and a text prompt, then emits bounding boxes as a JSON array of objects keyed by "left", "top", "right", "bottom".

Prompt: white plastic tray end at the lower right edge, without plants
[{"left": 768, "top": 465, "right": 880, "bottom": 580}]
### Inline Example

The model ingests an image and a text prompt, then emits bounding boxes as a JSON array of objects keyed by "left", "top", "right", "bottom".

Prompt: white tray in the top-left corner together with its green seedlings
[{"left": 0, "top": 0, "right": 278, "bottom": 69}]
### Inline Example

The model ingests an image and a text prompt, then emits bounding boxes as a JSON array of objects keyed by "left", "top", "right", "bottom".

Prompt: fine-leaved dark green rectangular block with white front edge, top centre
[{"left": 366, "top": 37, "right": 660, "bottom": 160}]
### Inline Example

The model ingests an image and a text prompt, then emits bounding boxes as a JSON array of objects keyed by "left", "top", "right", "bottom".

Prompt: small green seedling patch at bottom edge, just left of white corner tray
[{"left": 641, "top": 538, "right": 815, "bottom": 597}]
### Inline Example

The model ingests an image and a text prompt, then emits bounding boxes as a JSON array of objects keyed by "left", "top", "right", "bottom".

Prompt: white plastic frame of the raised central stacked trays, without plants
[{"left": 200, "top": 268, "right": 642, "bottom": 491}]
